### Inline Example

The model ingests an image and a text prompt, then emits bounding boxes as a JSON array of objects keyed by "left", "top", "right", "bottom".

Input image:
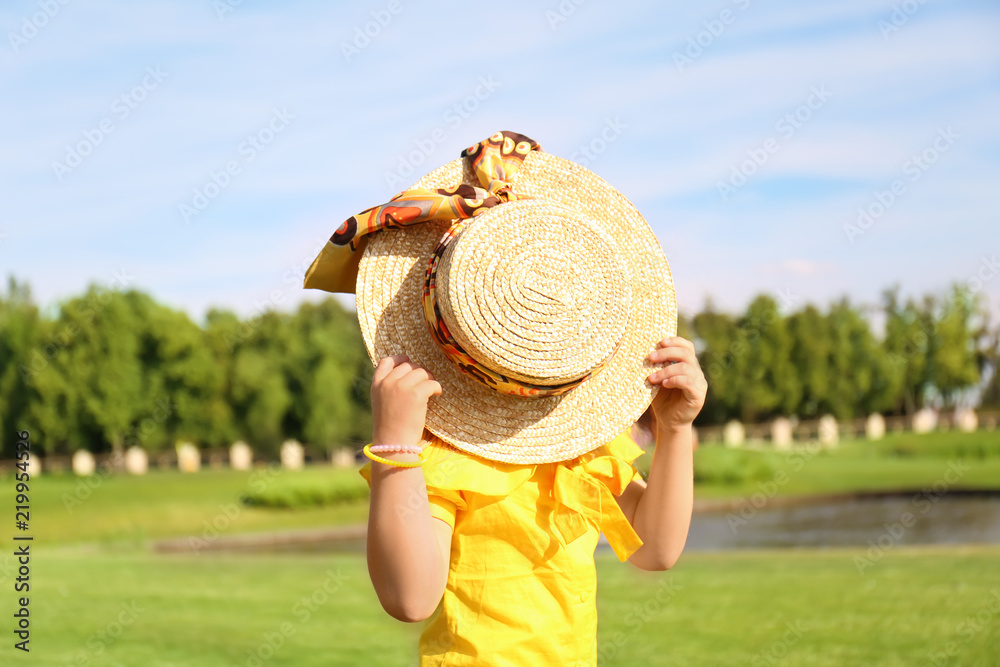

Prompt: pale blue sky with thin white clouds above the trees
[{"left": 0, "top": 0, "right": 1000, "bottom": 321}]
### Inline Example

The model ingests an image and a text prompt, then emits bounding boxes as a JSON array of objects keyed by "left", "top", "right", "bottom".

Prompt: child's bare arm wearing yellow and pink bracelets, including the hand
[{"left": 368, "top": 355, "right": 452, "bottom": 623}]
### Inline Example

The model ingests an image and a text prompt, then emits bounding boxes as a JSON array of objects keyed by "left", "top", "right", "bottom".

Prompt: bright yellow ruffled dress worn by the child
[{"left": 360, "top": 433, "right": 642, "bottom": 667}]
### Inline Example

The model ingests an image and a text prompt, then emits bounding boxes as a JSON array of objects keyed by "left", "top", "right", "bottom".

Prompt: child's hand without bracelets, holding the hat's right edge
[{"left": 648, "top": 336, "right": 708, "bottom": 430}]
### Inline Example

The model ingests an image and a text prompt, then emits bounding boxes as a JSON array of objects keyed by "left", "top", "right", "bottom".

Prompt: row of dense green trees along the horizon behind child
[{"left": 0, "top": 278, "right": 1000, "bottom": 458}]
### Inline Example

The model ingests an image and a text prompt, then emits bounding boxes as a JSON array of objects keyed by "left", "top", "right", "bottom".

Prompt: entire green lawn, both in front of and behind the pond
[{"left": 0, "top": 433, "right": 1000, "bottom": 667}]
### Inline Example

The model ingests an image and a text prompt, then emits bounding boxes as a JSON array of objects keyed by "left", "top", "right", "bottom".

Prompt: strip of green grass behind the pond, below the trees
[{"left": 0, "top": 431, "right": 1000, "bottom": 551}]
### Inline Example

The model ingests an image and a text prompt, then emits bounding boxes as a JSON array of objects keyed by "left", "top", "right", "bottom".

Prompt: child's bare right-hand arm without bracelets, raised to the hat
[{"left": 618, "top": 337, "right": 708, "bottom": 570}]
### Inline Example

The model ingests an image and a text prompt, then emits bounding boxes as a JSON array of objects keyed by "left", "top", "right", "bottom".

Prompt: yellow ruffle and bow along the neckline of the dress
[{"left": 359, "top": 431, "right": 643, "bottom": 562}]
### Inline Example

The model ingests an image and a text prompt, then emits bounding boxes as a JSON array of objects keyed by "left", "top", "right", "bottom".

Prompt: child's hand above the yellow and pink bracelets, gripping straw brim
[{"left": 372, "top": 354, "right": 441, "bottom": 445}]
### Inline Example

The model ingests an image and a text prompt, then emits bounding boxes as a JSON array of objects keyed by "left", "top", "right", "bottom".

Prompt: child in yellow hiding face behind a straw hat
[{"left": 306, "top": 132, "right": 707, "bottom": 666}]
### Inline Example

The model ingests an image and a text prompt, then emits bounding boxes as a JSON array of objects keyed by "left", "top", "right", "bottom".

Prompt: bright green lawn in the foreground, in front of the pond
[{"left": 0, "top": 547, "right": 1000, "bottom": 667}]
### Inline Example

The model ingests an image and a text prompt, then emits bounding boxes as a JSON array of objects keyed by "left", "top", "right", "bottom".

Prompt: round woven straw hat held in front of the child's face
[{"left": 305, "top": 133, "right": 677, "bottom": 464}]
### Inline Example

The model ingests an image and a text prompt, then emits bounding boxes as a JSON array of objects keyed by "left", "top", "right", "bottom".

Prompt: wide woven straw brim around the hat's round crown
[{"left": 356, "top": 151, "right": 677, "bottom": 464}]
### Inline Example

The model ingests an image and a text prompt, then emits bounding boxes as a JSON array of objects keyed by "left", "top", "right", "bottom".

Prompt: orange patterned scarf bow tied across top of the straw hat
[{"left": 330, "top": 132, "right": 542, "bottom": 249}]
